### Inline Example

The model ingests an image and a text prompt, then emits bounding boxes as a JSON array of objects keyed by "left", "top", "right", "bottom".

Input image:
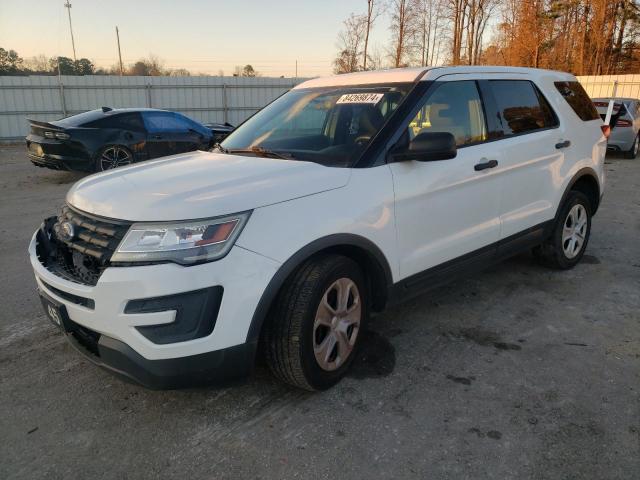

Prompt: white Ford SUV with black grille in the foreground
[{"left": 29, "top": 67, "right": 607, "bottom": 390}]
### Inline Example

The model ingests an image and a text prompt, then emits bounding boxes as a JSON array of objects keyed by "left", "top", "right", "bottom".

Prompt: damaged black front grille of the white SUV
[{"left": 36, "top": 206, "right": 131, "bottom": 285}]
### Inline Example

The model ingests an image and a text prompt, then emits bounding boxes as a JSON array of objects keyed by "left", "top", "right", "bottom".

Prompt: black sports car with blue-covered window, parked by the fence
[{"left": 26, "top": 107, "right": 215, "bottom": 172}]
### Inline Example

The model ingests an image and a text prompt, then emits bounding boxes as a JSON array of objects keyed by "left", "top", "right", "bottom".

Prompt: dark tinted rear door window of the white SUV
[{"left": 489, "top": 80, "right": 558, "bottom": 135}]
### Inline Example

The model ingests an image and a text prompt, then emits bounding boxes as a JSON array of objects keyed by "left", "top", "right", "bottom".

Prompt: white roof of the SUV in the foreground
[{"left": 295, "top": 65, "right": 575, "bottom": 89}]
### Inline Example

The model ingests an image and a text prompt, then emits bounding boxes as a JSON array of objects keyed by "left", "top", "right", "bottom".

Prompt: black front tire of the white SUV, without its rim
[{"left": 263, "top": 254, "right": 369, "bottom": 391}]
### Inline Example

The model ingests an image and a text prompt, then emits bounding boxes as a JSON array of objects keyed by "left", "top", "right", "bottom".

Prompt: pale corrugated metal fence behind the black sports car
[{"left": 0, "top": 75, "right": 305, "bottom": 142}]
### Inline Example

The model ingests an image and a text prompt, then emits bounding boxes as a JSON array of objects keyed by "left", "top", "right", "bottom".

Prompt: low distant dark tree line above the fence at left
[{"left": 0, "top": 47, "right": 260, "bottom": 77}]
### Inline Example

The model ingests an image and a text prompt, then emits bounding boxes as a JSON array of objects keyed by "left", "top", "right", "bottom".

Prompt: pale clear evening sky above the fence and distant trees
[{"left": 0, "top": 0, "right": 389, "bottom": 77}]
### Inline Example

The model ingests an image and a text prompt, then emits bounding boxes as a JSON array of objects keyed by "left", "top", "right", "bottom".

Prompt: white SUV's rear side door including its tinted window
[{"left": 480, "top": 76, "right": 564, "bottom": 239}]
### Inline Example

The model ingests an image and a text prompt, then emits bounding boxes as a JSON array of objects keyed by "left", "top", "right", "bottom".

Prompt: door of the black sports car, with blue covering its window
[{"left": 142, "top": 111, "right": 202, "bottom": 158}]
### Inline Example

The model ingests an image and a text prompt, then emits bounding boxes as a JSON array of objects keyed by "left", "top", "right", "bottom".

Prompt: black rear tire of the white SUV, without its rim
[{"left": 533, "top": 191, "right": 591, "bottom": 270}]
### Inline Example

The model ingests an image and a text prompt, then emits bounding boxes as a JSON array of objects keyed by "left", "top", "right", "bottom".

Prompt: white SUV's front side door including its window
[{"left": 390, "top": 75, "right": 502, "bottom": 279}]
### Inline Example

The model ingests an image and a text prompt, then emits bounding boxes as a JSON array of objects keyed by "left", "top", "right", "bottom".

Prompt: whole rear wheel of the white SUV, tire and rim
[{"left": 534, "top": 191, "right": 591, "bottom": 270}]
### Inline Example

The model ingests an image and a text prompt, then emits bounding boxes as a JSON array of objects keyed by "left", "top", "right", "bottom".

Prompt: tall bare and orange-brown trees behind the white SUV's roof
[{"left": 333, "top": 0, "right": 640, "bottom": 75}]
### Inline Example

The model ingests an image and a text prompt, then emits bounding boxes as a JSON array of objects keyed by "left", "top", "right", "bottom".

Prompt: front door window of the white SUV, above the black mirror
[{"left": 408, "top": 80, "right": 487, "bottom": 147}]
